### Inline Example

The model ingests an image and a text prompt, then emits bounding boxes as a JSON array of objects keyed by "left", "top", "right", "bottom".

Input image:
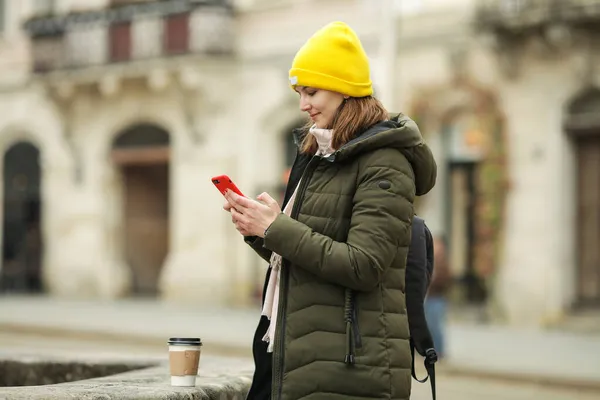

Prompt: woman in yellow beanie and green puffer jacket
[{"left": 224, "top": 22, "right": 436, "bottom": 400}]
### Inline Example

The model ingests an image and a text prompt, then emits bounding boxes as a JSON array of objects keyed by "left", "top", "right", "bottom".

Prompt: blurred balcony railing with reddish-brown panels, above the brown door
[{"left": 25, "top": 0, "right": 234, "bottom": 73}]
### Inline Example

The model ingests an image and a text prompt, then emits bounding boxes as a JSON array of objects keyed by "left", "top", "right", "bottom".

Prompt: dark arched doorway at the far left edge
[{"left": 0, "top": 142, "right": 43, "bottom": 293}]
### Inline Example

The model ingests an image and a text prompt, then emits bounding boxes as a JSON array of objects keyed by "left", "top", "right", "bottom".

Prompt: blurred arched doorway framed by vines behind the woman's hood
[{"left": 408, "top": 79, "right": 509, "bottom": 306}]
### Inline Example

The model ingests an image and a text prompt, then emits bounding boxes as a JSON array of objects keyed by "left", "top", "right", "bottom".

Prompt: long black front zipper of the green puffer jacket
[{"left": 271, "top": 156, "right": 320, "bottom": 400}]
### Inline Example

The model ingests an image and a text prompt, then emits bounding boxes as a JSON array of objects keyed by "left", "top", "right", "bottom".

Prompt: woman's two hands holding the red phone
[{"left": 223, "top": 190, "right": 281, "bottom": 237}]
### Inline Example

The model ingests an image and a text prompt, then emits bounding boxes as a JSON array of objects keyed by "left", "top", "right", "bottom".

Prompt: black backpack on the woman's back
[{"left": 406, "top": 215, "right": 438, "bottom": 400}]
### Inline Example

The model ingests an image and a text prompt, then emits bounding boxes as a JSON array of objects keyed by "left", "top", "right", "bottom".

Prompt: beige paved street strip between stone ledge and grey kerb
[{"left": 0, "top": 333, "right": 600, "bottom": 400}]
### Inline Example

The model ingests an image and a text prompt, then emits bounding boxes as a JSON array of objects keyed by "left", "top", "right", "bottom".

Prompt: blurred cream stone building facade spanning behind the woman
[{"left": 0, "top": 0, "right": 600, "bottom": 325}]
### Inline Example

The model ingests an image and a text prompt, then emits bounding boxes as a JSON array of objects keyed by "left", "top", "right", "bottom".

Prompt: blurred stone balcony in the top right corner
[{"left": 476, "top": 0, "right": 600, "bottom": 31}]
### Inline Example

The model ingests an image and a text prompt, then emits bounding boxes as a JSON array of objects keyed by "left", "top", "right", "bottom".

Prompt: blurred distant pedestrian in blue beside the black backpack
[{"left": 425, "top": 236, "right": 452, "bottom": 358}]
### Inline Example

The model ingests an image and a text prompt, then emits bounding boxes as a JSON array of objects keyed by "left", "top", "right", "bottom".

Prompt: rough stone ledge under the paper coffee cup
[{"left": 0, "top": 363, "right": 252, "bottom": 400}]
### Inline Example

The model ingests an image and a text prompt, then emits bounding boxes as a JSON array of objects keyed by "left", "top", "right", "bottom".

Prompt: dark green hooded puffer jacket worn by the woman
[{"left": 251, "top": 115, "right": 436, "bottom": 400}]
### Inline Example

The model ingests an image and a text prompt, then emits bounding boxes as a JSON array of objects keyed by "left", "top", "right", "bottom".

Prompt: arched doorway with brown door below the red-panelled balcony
[{"left": 112, "top": 125, "right": 170, "bottom": 296}]
